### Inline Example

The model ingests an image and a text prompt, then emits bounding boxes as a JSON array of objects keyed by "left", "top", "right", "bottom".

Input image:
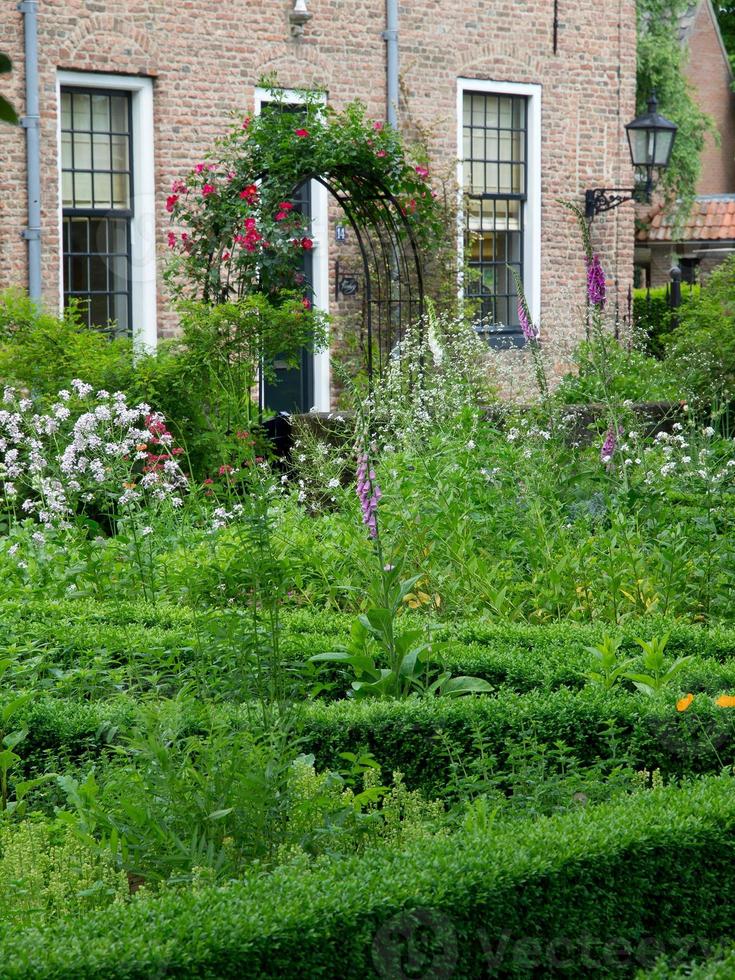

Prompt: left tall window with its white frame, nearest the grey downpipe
[{"left": 56, "top": 71, "right": 157, "bottom": 347}]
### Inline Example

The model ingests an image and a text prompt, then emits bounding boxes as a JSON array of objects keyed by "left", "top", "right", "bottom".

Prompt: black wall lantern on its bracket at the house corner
[{"left": 584, "top": 94, "right": 677, "bottom": 219}]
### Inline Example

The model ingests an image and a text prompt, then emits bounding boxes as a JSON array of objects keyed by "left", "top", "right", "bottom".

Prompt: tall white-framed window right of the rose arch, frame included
[{"left": 457, "top": 78, "right": 541, "bottom": 345}]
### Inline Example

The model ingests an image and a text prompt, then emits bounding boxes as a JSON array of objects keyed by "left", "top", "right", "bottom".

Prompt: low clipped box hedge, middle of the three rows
[{"left": 19, "top": 688, "right": 735, "bottom": 798}]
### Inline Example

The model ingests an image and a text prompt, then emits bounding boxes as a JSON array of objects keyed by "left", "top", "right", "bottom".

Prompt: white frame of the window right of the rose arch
[{"left": 457, "top": 78, "right": 543, "bottom": 331}]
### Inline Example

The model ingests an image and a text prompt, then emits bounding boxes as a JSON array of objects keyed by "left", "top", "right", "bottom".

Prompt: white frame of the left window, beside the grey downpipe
[{"left": 56, "top": 71, "right": 158, "bottom": 350}]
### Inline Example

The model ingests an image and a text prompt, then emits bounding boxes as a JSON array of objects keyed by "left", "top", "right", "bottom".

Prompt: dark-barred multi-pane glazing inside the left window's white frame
[{"left": 61, "top": 87, "right": 133, "bottom": 333}]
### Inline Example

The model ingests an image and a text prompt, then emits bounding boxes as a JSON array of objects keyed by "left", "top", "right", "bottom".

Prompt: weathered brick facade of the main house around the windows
[{"left": 0, "top": 0, "right": 635, "bottom": 380}]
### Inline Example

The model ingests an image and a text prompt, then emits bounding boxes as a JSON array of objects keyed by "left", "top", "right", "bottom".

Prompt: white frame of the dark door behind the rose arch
[{"left": 255, "top": 87, "right": 331, "bottom": 412}]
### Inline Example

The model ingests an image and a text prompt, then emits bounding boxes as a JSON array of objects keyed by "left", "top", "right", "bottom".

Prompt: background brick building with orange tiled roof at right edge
[{"left": 635, "top": 0, "right": 735, "bottom": 286}]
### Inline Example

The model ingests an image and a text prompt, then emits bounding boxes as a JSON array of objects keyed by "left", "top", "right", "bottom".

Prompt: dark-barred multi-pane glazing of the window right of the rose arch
[{"left": 462, "top": 91, "right": 528, "bottom": 337}]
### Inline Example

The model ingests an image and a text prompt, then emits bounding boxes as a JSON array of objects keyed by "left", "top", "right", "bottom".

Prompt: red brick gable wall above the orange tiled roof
[{"left": 687, "top": 0, "right": 735, "bottom": 194}]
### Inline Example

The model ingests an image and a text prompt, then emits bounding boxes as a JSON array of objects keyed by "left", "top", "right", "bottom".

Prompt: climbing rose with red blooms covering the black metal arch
[{"left": 166, "top": 90, "right": 442, "bottom": 302}]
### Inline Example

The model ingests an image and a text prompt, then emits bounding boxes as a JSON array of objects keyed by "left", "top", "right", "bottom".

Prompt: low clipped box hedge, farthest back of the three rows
[{"left": 7, "top": 601, "right": 735, "bottom": 693}]
